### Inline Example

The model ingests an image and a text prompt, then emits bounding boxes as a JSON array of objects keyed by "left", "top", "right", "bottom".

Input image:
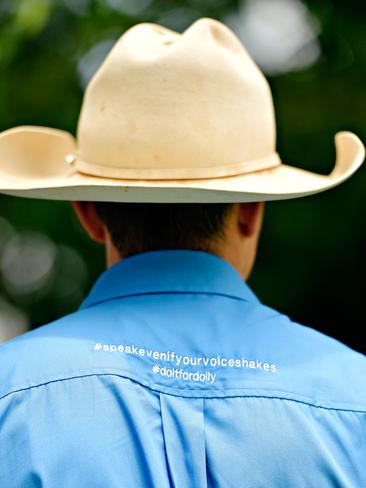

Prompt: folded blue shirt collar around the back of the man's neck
[{"left": 80, "top": 250, "right": 259, "bottom": 309}]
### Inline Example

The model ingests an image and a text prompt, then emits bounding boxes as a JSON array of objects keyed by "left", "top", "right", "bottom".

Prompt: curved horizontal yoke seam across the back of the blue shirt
[{"left": 0, "top": 373, "right": 366, "bottom": 414}]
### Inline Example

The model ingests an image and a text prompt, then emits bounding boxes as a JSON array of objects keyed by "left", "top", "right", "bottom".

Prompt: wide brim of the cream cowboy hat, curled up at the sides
[{"left": 0, "top": 126, "right": 365, "bottom": 203}]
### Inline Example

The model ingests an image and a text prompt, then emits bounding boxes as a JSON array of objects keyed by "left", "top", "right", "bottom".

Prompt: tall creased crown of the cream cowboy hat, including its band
[{"left": 72, "top": 18, "right": 281, "bottom": 180}]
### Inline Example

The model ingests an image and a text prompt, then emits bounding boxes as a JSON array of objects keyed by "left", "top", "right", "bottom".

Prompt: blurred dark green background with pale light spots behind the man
[{"left": 0, "top": 0, "right": 366, "bottom": 353}]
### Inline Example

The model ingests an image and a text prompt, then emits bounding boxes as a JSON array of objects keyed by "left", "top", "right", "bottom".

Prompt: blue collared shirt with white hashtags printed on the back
[{"left": 0, "top": 250, "right": 366, "bottom": 488}]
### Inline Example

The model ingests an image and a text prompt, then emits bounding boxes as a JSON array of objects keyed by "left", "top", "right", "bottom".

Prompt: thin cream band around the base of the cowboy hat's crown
[{"left": 66, "top": 153, "right": 281, "bottom": 180}]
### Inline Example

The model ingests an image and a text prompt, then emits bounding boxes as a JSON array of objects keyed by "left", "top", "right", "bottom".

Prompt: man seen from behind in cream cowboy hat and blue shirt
[{"left": 0, "top": 19, "right": 366, "bottom": 488}]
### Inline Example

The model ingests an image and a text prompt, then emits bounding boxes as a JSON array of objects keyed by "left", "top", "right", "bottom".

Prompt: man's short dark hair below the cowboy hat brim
[{"left": 94, "top": 202, "right": 233, "bottom": 257}]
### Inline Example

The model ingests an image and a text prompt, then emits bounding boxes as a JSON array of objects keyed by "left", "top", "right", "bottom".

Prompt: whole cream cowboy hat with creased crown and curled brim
[{"left": 0, "top": 18, "right": 365, "bottom": 203}]
